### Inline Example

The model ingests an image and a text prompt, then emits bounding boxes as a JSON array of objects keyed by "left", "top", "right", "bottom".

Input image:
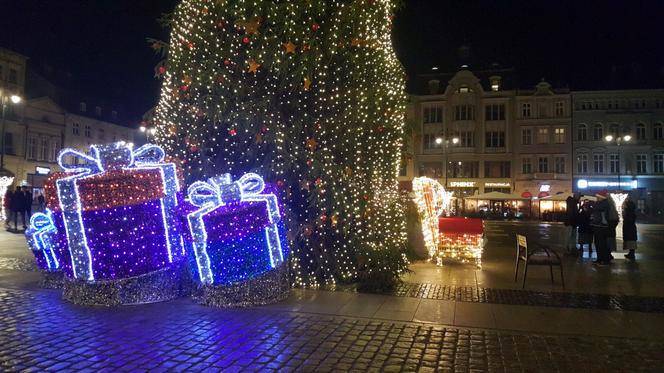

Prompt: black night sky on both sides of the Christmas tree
[{"left": 0, "top": 0, "right": 664, "bottom": 124}]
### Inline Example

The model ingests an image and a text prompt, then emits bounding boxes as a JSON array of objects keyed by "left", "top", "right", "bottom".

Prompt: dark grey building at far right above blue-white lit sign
[{"left": 572, "top": 89, "right": 664, "bottom": 216}]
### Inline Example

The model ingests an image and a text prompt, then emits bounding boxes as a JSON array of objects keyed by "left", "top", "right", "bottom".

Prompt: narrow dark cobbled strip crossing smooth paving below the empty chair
[{"left": 391, "top": 282, "right": 664, "bottom": 313}]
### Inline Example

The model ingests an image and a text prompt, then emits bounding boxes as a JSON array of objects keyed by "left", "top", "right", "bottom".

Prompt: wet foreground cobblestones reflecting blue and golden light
[{"left": 0, "top": 290, "right": 664, "bottom": 372}]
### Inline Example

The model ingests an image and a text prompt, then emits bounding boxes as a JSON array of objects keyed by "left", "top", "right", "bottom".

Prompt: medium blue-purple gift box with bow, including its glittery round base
[{"left": 187, "top": 173, "right": 289, "bottom": 306}]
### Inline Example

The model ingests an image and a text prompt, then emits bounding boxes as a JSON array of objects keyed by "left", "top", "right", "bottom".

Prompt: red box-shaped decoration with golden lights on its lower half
[{"left": 436, "top": 217, "right": 484, "bottom": 267}]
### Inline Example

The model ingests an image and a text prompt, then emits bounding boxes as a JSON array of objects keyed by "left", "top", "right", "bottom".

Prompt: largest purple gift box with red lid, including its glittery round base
[{"left": 45, "top": 142, "right": 184, "bottom": 304}]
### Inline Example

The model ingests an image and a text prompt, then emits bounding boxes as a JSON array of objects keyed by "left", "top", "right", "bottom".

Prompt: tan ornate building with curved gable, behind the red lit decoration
[{"left": 401, "top": 68, "right": 572, "bottom": 210}]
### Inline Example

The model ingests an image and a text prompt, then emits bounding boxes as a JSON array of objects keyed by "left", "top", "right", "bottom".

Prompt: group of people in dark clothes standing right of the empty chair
[{"left": 565, "top": 191, "right": 637, "bottom": 265}]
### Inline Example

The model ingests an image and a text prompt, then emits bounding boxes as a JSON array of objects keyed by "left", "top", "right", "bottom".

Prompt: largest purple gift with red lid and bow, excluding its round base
[{"left": 45, "top": 142, "right": 184, "bottom": 281}]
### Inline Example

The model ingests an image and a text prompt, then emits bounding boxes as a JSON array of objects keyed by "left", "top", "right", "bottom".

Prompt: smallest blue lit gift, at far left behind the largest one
[{"left": 25, "top": 209, "right": 61, "bottom": 271}]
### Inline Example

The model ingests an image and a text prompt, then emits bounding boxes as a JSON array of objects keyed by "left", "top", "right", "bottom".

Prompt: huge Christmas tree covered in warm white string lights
[{"left": 153, "top": 0, "right": 406, "bottom": 286}]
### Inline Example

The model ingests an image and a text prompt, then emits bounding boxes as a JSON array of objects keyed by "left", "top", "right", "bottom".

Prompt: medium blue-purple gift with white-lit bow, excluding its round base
[{"left": 187, "top": 173, "right": 287, "bottom": 285}]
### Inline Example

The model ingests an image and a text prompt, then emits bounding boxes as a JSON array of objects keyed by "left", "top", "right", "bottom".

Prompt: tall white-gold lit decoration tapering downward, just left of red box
[{"left": 413, "top": 177, "right": 452, "bottom": 259}]
